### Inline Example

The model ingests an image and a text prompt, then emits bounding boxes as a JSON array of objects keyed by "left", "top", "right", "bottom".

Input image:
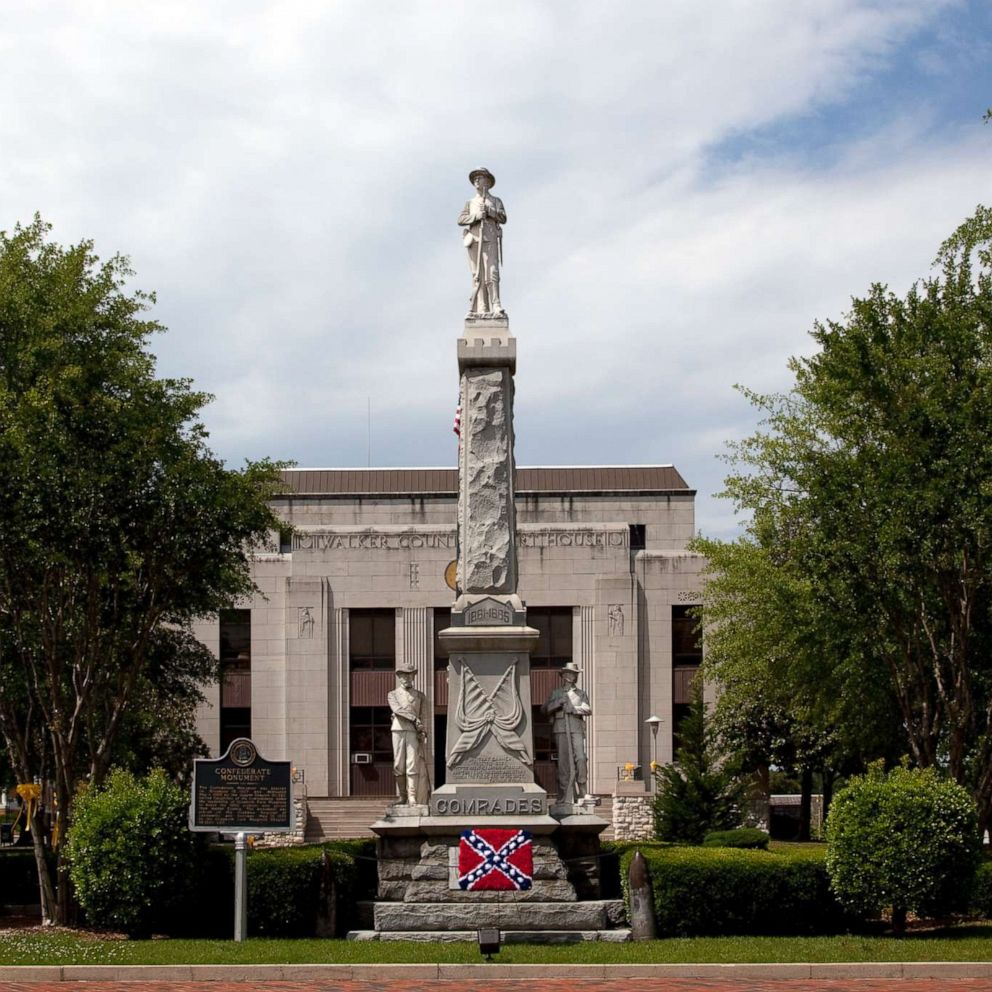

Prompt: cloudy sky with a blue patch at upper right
[{"left": 0, "top": 0, "right": 992, "bottom": 538}]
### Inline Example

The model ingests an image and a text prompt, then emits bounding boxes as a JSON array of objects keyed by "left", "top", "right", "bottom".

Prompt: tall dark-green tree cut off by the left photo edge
[{"left": 0, "top": 218, "right": 278, "bottom": 921}]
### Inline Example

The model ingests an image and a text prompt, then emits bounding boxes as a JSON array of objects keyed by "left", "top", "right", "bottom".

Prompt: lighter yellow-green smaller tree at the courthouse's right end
[{"left": 692, "top": 524, "right": 900, "bottom": 839}]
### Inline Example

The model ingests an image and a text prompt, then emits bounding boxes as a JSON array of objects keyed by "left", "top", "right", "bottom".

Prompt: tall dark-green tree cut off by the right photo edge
[{"left": 700, "top": 207, "right": 992, "bottom": 828}]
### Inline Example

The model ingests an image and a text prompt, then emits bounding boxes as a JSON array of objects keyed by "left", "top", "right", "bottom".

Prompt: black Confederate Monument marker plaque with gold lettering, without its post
[{"left": 189, "top": 737, "right": 293, "bottom": 834}]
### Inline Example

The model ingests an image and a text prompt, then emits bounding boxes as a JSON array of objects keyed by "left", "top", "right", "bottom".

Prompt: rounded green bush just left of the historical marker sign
[{"left": 67, "top": 769, "right": 197, "bottom": 937}]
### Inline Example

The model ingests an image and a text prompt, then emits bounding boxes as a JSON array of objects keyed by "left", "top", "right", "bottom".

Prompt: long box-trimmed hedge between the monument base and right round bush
[{"left": 620, "top": 846, "right": 852, "bottom": 937}]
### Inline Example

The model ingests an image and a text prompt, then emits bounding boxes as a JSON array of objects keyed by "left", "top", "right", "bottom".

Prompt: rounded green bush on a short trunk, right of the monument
[{"left": 827, "top": 765, "right": 980, "bottom": 930}]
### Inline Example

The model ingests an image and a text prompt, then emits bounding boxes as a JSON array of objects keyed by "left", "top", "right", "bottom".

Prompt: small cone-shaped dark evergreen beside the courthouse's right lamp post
[{"left": 654, "top": 679, "right": 743, "bottom": 844}]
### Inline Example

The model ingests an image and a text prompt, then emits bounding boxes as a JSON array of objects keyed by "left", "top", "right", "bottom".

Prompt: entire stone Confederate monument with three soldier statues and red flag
[{"left": 360, "top": 169, "right": 628, "bottom": 941}]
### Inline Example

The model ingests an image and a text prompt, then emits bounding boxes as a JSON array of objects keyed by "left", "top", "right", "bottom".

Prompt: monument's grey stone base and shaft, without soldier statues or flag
[{"left": 349, "top": 318, "right": 628, "bottom": 941}]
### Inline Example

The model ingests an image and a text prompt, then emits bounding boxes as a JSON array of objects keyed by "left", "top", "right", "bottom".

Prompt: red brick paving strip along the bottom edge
[{"left": 0, "top": 969, "right": 992, "bottom": 992}]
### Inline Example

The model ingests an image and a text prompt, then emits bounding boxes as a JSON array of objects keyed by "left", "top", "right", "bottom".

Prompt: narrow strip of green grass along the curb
[{"left": 0, "top": 924, "right": 992, "bottom": 965}]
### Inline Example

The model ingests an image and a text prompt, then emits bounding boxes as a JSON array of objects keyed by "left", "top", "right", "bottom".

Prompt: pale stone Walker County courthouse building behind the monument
[{"left": 198, "top": 465, "right": 702, "bottom": 836}]
